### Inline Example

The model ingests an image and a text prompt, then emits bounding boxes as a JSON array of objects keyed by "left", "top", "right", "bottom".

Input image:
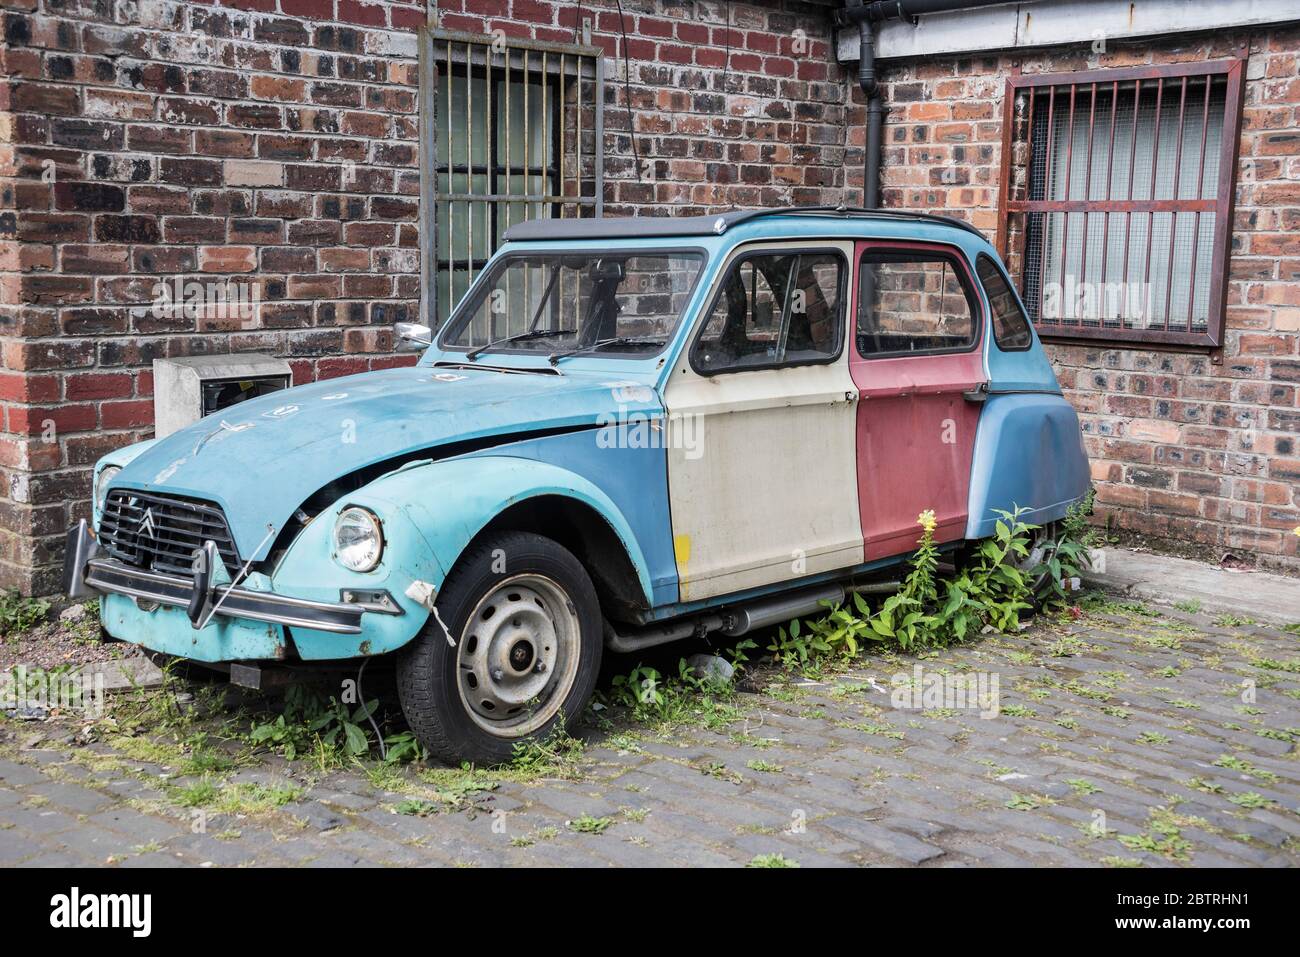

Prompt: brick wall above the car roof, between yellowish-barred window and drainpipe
[{"left": 437, "top": 0, "right": 846, "bottom": 216}]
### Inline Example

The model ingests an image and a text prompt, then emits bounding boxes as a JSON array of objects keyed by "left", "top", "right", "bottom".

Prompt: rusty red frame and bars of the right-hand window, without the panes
[{"left": 996, "top": 56, "right": 1245, "bottom": 350}]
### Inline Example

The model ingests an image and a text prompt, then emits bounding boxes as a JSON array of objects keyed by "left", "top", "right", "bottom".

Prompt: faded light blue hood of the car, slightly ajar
[{"left": 111, "top": 365, "right": 662, "bottom": 559}]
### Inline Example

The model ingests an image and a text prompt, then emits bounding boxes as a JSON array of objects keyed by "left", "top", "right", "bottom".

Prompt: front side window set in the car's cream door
[{"left": 690, "top": 252, "right": 844, "bottom": 374}]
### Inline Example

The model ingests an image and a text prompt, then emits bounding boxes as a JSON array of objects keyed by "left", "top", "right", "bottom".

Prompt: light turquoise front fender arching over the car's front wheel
[{"left": 273, "top": 454, "right": 651, "bottom": 661}]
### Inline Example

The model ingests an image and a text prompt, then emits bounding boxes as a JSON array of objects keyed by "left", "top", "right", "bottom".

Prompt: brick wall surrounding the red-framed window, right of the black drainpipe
[{"left": 848, "top": 27, "right": 1300, "bottom": 575}]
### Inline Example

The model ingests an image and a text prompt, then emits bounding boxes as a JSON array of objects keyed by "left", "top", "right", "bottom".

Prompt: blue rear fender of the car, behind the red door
[{"left": 966, "top": 393, "right": 1091, "bottom": 538}]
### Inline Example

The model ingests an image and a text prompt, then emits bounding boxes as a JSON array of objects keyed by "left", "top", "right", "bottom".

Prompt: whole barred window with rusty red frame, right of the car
[{"left": 998, "top": 59, "right": 1245, "bottom": 347}]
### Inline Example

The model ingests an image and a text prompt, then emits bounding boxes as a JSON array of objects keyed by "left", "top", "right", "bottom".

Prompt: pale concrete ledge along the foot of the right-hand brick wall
[{"left": 1083, "top": 549, "right": 1300, "bottom": 625}]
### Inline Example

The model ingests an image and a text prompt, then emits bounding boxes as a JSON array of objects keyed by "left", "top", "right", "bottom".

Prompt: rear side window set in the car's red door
[{"left": 857, "top": 250, "right": 980, "bottom": 359}]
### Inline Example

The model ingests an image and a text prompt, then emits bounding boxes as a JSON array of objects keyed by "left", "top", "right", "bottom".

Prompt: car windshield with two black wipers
[{"left": 442, "top": 251, "right": 705, "bottom": 358}]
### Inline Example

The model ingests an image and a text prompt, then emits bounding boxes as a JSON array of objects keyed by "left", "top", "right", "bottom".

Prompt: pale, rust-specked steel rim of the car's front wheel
[{"left": 456, "top": 573, "right": 580, "bottom": 737}]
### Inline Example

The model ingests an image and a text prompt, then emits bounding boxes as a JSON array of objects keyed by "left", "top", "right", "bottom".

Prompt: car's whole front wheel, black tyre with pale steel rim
[{"left": 398, "top": 532, "right": 602, "bottom": 765}]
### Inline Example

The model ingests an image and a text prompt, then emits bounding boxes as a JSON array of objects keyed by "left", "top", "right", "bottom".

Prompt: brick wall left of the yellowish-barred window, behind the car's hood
[{"left": 0, "top": 0, "right": 425, "bottom": 592}]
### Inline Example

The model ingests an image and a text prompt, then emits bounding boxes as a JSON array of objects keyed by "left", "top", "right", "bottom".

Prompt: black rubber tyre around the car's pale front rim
[{"left": 398, "top": 532, "right": 603, "bottom": 766}]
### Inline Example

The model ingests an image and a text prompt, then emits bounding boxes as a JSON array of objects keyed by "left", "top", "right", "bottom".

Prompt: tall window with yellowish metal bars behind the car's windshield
[{"left": 420, "top": 27, "right": 605, "bottom": 328}]
